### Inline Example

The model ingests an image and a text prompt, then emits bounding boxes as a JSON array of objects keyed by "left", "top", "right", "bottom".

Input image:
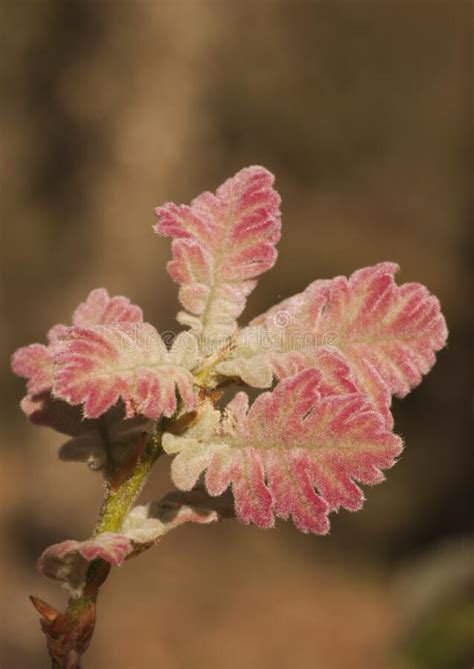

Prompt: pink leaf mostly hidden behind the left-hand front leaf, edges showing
[{"left": 12, "top": 288, "right": 143, "bottom": 415}]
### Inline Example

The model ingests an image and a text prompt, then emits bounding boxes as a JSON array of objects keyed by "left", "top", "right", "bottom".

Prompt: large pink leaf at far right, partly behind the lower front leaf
[{"left": 218, "top": 262, "right": 447, "bottom": 424}]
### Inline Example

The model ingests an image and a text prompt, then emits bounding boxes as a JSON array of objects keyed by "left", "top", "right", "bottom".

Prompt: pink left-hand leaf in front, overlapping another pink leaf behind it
[{"left": 53, "top": 323, "right": 197, "bottom": 419}]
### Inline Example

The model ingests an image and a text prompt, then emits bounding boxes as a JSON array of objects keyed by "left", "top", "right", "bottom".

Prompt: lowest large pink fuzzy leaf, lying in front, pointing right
[{"left": 163, "top": 369, "right": 402, "bottom": 534}]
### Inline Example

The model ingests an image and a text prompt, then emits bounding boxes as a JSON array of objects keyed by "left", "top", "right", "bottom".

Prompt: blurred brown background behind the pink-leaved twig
[{"left": 0, "top": 0, "right": 474, "bottom": 669}]
